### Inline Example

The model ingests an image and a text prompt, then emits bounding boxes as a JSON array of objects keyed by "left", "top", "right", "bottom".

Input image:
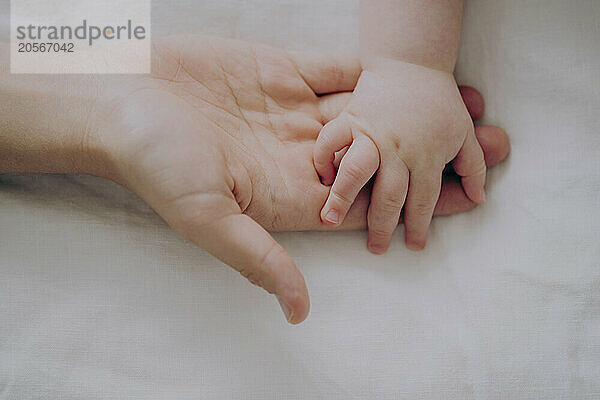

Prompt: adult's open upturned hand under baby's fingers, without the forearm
[{"left": 98, "top": 36, "right": 508, "bottom": 323}]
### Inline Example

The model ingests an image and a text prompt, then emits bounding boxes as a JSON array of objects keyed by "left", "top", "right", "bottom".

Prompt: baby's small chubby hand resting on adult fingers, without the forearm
[{"left": 314, "top": 61, "right": 486, "bottom": 253}]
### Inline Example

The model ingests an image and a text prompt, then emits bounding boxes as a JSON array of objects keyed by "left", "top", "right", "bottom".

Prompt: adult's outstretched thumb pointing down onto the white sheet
[{"left": 190, "top": 214, "right": 310, "bottom": 324}]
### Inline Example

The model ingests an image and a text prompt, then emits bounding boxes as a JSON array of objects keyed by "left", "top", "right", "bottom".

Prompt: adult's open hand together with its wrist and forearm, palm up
[{"left": 0, "top": 36, "right": 509, "bottom": 324}]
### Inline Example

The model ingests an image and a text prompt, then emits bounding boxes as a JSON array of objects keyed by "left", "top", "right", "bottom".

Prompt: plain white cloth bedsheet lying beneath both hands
[{"left": 0, "top": 0, "right": 600, "bottom": 399}]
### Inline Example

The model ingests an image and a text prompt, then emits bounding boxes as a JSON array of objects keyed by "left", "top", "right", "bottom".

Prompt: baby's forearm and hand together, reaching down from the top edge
[{"left": 314, "top": 0, "right": 486, "bottom": 253}]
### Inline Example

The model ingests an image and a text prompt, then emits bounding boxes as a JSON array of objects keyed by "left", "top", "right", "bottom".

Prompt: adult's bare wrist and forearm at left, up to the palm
[{"left": 0, "top": 71, "right": 117, "bottom": 180}]
